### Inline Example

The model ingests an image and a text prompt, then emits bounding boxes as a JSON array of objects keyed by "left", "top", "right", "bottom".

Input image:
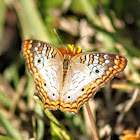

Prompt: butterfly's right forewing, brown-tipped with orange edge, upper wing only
[{"left": 72, "top": 52, "right": 127, "bottom": 86}]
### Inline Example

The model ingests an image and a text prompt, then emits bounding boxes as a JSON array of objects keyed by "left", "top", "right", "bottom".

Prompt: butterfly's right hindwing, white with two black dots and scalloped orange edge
[{"left": 60, "top": 63, "right": 97, "bottom": 114}]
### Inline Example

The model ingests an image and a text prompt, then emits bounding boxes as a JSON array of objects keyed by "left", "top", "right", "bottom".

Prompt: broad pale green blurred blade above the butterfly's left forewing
[{"left": 13, "top": 0, "right": 51, "bottom": 42}]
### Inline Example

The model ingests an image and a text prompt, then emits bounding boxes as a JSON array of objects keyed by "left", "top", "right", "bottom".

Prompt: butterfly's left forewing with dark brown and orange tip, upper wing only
[{"left": 22, "top": 40, "right": 62, "bottom": 75}]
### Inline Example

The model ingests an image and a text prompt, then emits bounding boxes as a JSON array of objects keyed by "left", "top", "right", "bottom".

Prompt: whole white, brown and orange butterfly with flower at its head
[{"left": 22, "top": 39, "right": 127, "bottom": 114}]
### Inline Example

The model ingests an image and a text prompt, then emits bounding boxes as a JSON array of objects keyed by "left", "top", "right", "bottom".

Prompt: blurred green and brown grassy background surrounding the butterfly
[{"left": 0, "top": 0, "right": 140, "bottom": 140}]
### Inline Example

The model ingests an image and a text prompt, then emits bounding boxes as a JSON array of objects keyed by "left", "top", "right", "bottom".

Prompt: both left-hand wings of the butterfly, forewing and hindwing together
[{"left": 22, "top": 40, "right": 63, "bottom": 109}]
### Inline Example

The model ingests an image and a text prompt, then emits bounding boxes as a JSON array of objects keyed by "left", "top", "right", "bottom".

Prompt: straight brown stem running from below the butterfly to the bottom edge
[{"left": 85, "top": 102, "right": 99, "bottom": 140}]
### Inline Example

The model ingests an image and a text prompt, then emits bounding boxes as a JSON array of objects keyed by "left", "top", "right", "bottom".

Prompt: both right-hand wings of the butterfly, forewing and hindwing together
[{"left": 60, "top": 53, "right": 127, "bottom": 113}]
